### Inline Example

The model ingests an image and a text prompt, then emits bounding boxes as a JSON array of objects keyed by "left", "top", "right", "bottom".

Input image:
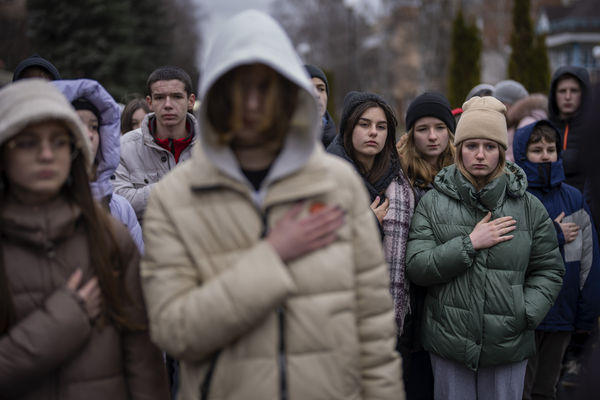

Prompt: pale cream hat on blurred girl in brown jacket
[{"left": 0, "top": 79, "right": 92, "bottom": 165}]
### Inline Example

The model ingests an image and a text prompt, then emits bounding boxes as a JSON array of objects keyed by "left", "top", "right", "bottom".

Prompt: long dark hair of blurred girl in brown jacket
[{"left": 0, "top": 123, "right": 145, "bottom": 334}]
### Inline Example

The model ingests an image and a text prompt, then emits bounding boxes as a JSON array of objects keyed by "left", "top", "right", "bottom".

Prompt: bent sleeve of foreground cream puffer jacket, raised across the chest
[{"left": 142, "top": 181, "right": 295, "bottom": 361}]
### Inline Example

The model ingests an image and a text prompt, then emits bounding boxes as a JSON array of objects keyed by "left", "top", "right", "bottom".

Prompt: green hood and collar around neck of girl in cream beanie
[{"left": 433, "top": 161, "right": 527, "bottom": 212}]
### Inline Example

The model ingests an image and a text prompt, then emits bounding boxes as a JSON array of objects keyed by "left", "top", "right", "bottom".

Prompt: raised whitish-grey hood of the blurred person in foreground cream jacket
[{"left": 194, "top": 10, "right": 321, "bottom": 203}]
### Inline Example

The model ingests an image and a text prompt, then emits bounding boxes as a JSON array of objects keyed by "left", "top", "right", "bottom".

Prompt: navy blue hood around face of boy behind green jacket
[{"left": 513, "top": 120, "right": 565, "bottom": 191}]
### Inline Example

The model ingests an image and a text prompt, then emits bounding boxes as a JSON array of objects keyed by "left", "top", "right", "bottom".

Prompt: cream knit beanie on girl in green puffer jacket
[{"left": 454, "top": 96, "right": 508, "bottom": 150}]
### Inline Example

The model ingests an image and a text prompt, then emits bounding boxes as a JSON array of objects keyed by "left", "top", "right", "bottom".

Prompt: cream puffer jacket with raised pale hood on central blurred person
[{"left": 142, "top": 11, "right": 404, "bottom": 400}]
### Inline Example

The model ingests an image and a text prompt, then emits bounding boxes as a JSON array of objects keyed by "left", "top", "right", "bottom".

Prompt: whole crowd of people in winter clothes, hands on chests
[{"left": 0, "top": 11, "right": 600, "bottom": 400}]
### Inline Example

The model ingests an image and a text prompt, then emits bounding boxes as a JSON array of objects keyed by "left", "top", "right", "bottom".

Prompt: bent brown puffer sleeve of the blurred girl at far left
[{"left": 0, "top": 289, "right": 91, "bottom": 390}]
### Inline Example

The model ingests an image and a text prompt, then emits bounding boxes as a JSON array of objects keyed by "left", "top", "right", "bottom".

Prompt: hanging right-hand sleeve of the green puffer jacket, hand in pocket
[{"left": 523, "top": 193, "right": 565, "bottom": 330}]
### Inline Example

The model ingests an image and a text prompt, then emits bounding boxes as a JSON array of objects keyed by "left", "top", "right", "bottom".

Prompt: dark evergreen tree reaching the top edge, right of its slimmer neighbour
[{"left": 508, "top": 0, "right": 550, "bottom": 92}]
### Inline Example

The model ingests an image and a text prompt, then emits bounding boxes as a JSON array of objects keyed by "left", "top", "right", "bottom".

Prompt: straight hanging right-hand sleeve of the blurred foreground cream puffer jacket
[{"left": 347, "top": 173, "right": 404, "bottom": 399}]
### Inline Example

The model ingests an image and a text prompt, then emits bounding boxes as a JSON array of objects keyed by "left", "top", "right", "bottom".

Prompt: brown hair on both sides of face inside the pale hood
[{"left": 205, "top": 65, "right": 298, "bottom": 145}]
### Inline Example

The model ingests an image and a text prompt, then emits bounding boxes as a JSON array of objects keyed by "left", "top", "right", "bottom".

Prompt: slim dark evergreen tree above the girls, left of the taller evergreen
[{"left": 448, "top": 9, "right": 482, "bottom": 107}]
